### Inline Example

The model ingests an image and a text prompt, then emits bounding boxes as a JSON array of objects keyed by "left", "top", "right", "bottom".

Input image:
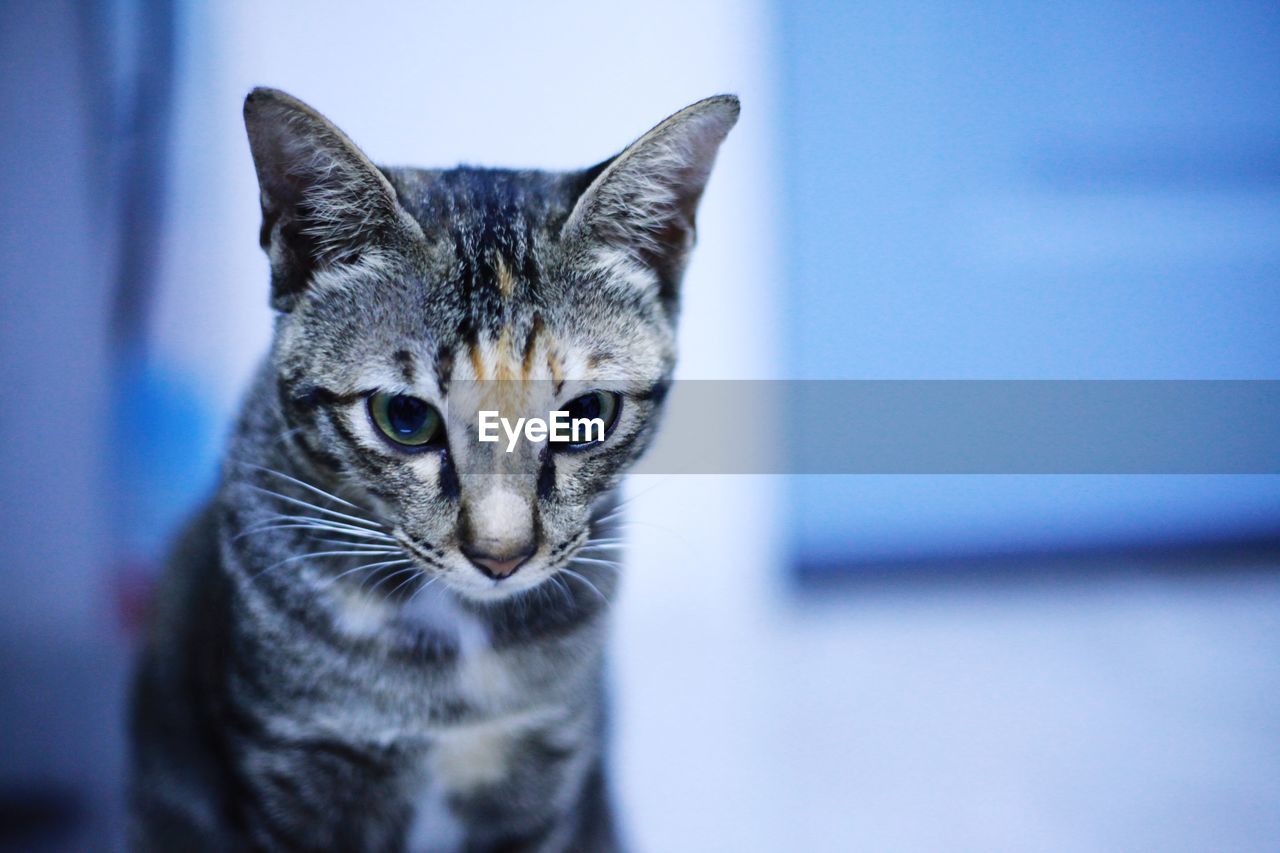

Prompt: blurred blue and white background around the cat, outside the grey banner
[{"left": 0, "top": 0, "right": 1280, "bottom": 850}]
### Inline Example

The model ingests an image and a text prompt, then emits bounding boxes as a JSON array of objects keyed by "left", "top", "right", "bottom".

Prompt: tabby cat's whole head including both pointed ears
[{"left": 244, "top": 90, "right": 739, "bottom": 599}]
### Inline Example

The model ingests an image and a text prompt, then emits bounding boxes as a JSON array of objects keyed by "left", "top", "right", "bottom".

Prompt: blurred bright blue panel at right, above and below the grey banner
[{"left": 777, "top": 1, "right": 1280, "bottom": 571}]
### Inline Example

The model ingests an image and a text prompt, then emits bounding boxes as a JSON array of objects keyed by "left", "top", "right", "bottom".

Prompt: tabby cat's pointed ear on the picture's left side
[{"left": 244, "top": 88, "right": 421, "bottom": 311}]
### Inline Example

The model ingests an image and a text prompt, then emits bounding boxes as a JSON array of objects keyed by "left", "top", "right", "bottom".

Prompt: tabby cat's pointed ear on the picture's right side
[{"left": 561, "top": 95, "right": 739, "bottom": 306}]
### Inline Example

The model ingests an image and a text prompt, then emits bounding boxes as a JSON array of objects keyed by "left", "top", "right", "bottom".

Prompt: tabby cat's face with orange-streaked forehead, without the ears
[{"left": 276, "top": 199, "right": 675, "bottom": 598}]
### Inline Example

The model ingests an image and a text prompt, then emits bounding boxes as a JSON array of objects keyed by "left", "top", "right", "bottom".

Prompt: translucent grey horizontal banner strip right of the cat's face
[{"left": 637, "top": 380, "right": 1280, "bottom": 474}]
